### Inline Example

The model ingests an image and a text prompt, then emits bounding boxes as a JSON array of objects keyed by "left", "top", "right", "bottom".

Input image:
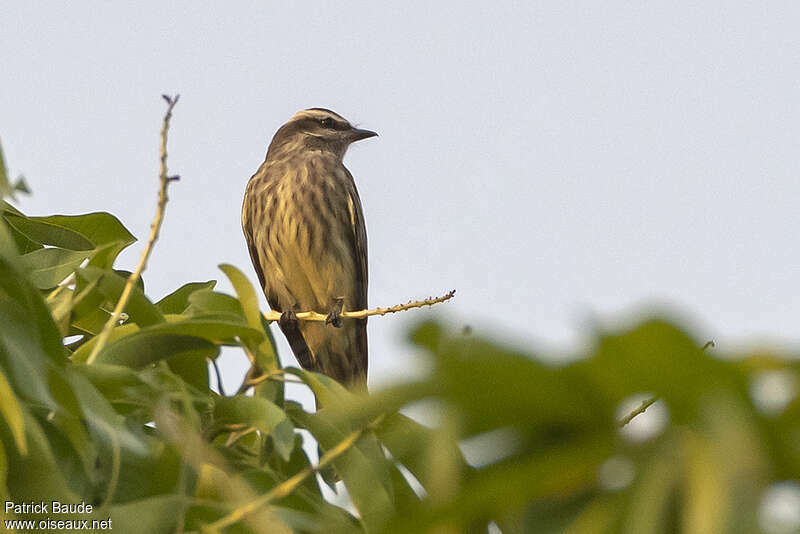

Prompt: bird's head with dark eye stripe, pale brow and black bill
[{"left": 267, "top": 108, "right": 378, "bottom": 159}]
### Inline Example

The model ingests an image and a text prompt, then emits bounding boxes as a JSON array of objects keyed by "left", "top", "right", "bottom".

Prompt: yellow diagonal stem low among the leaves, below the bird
[{"left": 200, "top": 415, "right": 383, "bottom": 533}]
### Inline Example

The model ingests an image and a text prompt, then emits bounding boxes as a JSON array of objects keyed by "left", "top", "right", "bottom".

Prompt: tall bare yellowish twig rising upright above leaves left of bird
[{"left": 86, "top": 95, "right": 180, "bottom": 364}]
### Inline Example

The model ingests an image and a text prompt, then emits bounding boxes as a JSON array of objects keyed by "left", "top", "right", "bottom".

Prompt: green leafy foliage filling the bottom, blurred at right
[{"left": 0, "top": 150, "right": 800, "bottom": 534}]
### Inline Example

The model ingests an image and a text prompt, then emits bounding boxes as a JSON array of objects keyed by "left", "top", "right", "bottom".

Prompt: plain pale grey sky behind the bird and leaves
[{"left": 0, "top": 1, "right": 800, "bottom": 402}]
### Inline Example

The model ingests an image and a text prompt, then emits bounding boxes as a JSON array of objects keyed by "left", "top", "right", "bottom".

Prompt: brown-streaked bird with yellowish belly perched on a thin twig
[{"left": 242, "top": 108, "right": 378, "bottom": 391}]
